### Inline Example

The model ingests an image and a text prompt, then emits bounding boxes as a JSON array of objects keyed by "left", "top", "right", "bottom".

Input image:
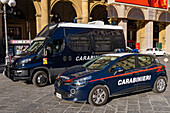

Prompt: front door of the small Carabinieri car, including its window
[{"left": 107, "top": 56, "right": 137, "bottom": 95}]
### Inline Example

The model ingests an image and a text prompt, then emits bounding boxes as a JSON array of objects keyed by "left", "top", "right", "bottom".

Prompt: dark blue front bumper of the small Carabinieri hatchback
[{"left": 54, "top": 82, "right": 92, "bottom": 102}]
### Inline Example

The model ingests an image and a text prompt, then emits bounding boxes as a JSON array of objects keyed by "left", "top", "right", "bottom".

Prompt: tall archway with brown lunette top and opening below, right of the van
[{"left": 127, "top": 8, "right": 145, "bottom": 49}]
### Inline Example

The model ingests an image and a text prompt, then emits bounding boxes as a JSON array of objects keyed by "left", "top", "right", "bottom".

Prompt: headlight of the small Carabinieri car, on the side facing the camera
[{"left": 71, "top": 76, "right": 91, "bottom": 86}]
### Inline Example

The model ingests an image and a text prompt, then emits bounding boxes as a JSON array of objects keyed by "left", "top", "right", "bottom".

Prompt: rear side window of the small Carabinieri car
[{"left": 138, "top": 56, "right": 154, "bottom": 67}]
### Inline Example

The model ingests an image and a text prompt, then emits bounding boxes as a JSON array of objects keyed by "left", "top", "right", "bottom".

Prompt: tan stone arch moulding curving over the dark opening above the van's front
[{"left": 49, "top": 0, "right": 82, "bottom": 17}]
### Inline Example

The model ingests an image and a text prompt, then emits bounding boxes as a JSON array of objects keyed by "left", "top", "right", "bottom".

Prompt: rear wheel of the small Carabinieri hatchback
[{"left": 152, "top": 76, "right": 167, "bottom": 93}]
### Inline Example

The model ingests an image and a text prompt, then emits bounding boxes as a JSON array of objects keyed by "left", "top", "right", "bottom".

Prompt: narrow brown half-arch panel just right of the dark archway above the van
[{"left": 107, "top": 5, "right": 118, "bottom": 18}]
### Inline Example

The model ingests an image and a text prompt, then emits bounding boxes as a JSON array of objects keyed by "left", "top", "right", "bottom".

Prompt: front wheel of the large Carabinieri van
[{"left": 32, "top": 71, "right": 48, "bottom": 87}]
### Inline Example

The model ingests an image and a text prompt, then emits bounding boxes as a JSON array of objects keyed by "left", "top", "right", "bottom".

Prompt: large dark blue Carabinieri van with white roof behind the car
[{"left": 5, "top": 21, "right": 125, "bottom": 87}]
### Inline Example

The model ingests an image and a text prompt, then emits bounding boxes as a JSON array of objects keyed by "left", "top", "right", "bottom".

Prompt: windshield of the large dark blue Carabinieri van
[{"left": 26, "top": 40, "right": 45, "bottom": 53}]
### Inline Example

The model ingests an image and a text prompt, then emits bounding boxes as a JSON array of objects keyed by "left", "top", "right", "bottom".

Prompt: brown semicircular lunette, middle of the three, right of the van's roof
[{"left": 127, "top": 7, "right": 145, "bottom": 20}]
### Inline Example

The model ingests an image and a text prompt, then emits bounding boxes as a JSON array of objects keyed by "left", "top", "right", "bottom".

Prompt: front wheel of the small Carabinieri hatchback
[{"left": 88, "top": 85, "right": 108, "bottom": 106}]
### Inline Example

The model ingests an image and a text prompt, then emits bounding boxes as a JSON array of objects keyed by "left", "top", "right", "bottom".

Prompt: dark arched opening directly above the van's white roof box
[{"left": 90, "top": 5, "right": 109, "bottom": 24}]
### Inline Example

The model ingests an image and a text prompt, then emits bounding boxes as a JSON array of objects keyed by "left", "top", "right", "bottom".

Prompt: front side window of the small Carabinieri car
[{"left": 112, "top": 56, "right": 135, "bottom": 70}]
